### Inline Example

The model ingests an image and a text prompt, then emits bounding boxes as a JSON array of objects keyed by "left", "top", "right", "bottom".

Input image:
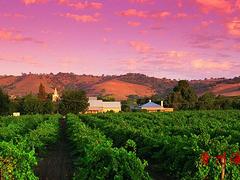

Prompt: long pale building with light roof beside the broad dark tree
[{"left": 86, "top": 97, "right": 121, "bottom": 113}]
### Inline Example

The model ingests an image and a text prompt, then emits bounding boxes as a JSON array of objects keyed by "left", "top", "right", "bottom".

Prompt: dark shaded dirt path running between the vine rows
[{"left": 36, "top": 119, "right": 72, "bottom": 180}]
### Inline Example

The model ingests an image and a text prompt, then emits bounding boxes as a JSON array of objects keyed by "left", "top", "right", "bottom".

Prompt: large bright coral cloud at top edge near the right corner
[{"left": 196, "top": 0, "right": 232, "bottom": 13}]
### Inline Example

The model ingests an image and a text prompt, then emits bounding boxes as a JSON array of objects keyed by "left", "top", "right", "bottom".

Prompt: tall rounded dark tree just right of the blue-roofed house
[{"left": 167, "top": 80, "right": 197, "bottom": 109}]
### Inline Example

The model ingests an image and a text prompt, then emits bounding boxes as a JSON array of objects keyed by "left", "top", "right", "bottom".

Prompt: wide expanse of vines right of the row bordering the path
[{"left": 80, "top": 111, "right": 240, "bottom": 179}]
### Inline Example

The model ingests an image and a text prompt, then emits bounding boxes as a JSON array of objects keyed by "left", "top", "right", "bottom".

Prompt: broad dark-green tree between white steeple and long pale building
[{"left": 59, "top": 90, "right": 89, "bottom": 114}]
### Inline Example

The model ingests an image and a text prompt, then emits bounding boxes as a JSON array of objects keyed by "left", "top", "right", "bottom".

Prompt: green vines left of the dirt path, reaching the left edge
[{"left": 0, "top": 115, "right": 60, "bottom": 180}]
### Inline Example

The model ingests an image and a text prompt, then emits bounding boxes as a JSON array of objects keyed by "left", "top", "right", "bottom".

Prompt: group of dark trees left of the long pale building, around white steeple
[{"left": 0, "top": 84, "right": 88, "bottom": 115}]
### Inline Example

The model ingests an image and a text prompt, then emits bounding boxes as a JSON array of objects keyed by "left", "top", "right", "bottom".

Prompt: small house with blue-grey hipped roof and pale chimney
[{"left": 140, "top": 100, "right": 173, "bottom": 112}]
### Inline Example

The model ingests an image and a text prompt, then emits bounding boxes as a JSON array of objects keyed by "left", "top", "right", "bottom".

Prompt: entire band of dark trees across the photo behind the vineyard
[{"left": 0, "top": 80, "right": 240, "bottom": 115}]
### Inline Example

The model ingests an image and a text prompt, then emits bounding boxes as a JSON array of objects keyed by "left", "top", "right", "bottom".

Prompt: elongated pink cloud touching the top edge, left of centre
[{"left": 58, "top": 0, "right": 103, "bottom": 9}]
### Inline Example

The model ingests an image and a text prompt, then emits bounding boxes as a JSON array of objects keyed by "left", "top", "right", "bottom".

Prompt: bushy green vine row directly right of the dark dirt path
[{"left": 67, "top": 114, "right": 150, "bottom": 180}]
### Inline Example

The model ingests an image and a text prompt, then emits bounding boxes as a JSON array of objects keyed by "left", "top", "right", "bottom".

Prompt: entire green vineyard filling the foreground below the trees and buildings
[{"left": 0, "top": 111, "right": 240, "bottom": 180}]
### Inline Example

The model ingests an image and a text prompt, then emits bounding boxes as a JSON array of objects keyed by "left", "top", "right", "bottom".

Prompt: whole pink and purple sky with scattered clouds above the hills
[{"left": 0, "top": 0, "right": 240, "bottom": 79}]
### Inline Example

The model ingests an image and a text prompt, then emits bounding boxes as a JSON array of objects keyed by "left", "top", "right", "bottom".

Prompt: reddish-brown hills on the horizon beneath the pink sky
[{"left": 0, "top": 73, "right": 240, "bottom": 100}]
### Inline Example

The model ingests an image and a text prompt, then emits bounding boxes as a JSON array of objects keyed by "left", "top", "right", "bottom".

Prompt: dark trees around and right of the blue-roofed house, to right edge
[{"left": 122, "top": 80, "right": 240, "bottom": 112}]
